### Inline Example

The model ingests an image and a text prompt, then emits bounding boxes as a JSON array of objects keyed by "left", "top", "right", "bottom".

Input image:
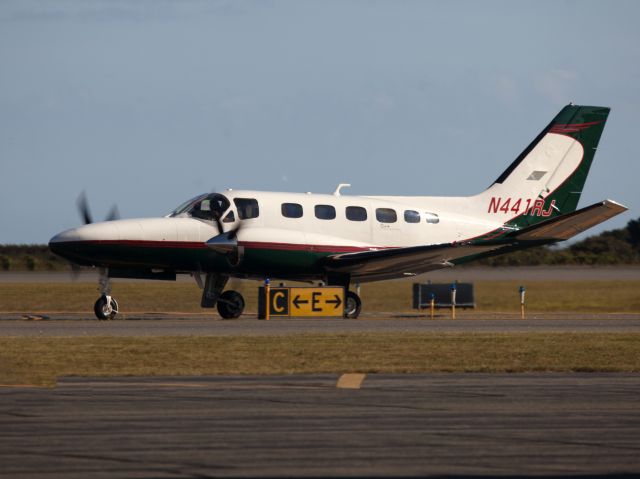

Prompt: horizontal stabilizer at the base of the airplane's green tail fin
[{"left": 513, "top": 200, "right": 628, "bottom": 241}]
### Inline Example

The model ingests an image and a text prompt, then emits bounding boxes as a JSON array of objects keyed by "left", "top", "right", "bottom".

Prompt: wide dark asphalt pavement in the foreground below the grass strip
[{"left": 0, "top": 374, "right": 640, "bottom": 478}]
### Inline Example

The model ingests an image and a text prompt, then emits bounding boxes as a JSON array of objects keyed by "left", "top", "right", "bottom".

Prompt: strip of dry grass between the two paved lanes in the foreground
[{"left": 0, "top": 333, "right": 640, "bottom": 385}]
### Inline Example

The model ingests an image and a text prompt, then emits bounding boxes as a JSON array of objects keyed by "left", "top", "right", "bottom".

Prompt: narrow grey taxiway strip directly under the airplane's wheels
[{"left": 0, "top": 314, "right": 640, "bottom": 337}]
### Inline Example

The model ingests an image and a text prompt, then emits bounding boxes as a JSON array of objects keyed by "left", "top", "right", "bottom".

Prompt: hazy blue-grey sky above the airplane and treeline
[{"left": 0, "top": 0, "right": 640, "bottom": 243}]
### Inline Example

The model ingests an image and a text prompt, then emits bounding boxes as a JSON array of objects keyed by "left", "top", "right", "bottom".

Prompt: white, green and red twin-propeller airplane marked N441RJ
[{"left": 49, "top": 104, "right": 627, "bottom": 319}]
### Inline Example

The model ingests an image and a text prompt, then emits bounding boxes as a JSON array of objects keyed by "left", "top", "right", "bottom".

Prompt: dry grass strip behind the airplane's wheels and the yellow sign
[{"left": 0, "top": 281, "right": 640, "bottom": 314}]
